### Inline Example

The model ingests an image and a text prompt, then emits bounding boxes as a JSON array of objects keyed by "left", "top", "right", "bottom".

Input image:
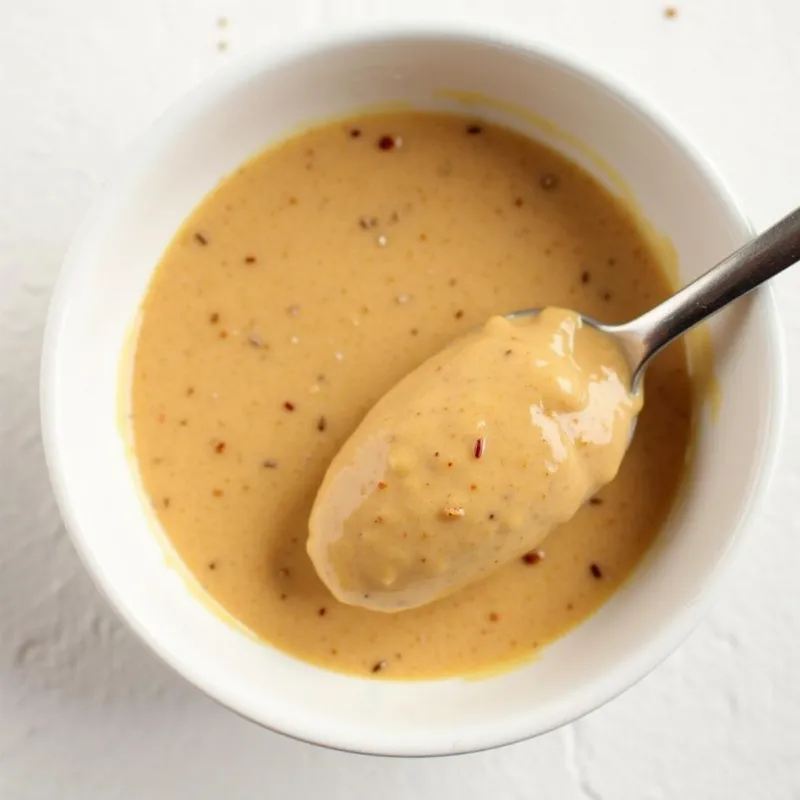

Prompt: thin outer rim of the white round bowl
[{"left": 40, "top": 21, "right": 786, "bottom": 757}]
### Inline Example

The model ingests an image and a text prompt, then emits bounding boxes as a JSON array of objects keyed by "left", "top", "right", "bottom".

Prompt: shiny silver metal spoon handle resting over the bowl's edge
[{"left": 507, "top": 208, "right": 800, "bottom": 393}]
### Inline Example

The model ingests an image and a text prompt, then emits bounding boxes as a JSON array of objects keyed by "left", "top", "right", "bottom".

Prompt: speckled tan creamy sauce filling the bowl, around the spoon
[{"left": 131, "top": 112, "right": 692, "bottom": 678}]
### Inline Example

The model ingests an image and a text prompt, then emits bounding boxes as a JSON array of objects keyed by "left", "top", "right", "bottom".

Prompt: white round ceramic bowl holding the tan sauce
[{"left": 41, "top": 30, "right": 782, "bottom": 755}]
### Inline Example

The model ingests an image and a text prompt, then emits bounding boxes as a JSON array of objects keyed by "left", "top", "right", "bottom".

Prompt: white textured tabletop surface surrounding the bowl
[{"left": 0, "top": 0, "right": 800, "bottom": 800}]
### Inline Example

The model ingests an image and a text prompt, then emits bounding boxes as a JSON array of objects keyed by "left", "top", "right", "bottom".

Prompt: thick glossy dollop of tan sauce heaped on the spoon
[{"left": 307, "top": 308, "right": 643, "bottom": 612}]
